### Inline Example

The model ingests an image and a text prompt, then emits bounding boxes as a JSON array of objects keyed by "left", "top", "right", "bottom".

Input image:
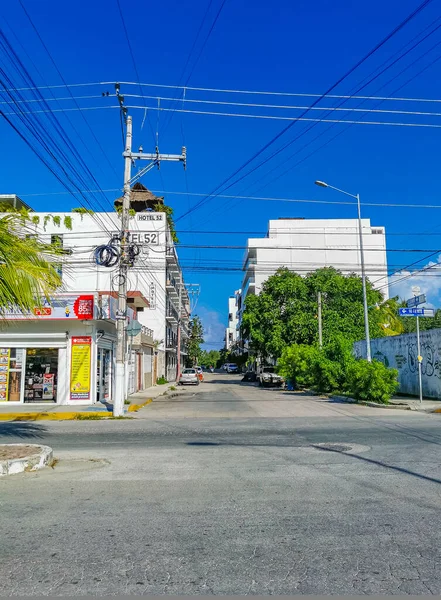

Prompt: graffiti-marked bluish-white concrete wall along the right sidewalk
[{"left": 354, "top": 329, "right": 441, "bottom": 399}]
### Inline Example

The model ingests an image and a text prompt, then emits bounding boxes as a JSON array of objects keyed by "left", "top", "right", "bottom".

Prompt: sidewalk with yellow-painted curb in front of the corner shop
[{"left": 0, "top": 382, "right": 176, "bottom": 421}]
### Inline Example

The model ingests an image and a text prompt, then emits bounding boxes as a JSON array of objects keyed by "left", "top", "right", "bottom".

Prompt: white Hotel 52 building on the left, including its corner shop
[{"left": 0, "top": 184, "right": 190, "bottom": 404}]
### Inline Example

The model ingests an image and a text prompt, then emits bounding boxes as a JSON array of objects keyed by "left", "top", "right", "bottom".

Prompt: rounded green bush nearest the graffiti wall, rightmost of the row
[{"left": 347, "top": 359, "right": 398, "bottom": 404}]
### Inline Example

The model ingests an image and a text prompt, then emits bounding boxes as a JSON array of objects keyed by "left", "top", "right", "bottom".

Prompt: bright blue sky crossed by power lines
[{"left": 0, "top": 0, "right": 441, "bottom": 344}]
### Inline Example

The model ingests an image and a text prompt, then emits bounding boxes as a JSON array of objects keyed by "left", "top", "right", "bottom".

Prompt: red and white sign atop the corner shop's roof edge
[{"left": 3, "top": 294, "right": 95, "bottom": 321}]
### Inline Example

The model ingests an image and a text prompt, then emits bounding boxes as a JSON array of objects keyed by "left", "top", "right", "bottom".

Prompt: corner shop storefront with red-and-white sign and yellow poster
[{"left": 0, "top": 294, "right": 116, "bottom": 405}]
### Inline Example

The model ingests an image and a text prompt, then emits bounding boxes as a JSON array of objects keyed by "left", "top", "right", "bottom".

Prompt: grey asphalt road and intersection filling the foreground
[{"left": 0, "top": 375, "right": 441, "bottom": 596}]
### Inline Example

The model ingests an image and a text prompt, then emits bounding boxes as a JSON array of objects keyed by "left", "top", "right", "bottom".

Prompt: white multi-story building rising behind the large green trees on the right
[{"left": 238, "top": 218, "right": 388, "bottom": 328}]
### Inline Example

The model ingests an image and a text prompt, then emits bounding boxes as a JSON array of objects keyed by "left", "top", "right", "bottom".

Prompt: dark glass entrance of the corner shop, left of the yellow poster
[{"left": 24, "top": 348, "right": 58, "bottom": 403}]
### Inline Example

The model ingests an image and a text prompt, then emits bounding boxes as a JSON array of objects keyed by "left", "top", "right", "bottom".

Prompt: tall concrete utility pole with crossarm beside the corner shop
[{"left": 113, "top": 116, "right": 132, "bottom": 417}]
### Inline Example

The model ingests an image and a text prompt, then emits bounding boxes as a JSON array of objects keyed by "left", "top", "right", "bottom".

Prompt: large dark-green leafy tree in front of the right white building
[{"left": 242, "top": 267, "right": 385, "bottom": 360}]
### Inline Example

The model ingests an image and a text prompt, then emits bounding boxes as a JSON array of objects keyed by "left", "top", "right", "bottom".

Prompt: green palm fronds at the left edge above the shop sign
[{"left": 0, "top": 214, "right": 61, "bottom": 313}]
